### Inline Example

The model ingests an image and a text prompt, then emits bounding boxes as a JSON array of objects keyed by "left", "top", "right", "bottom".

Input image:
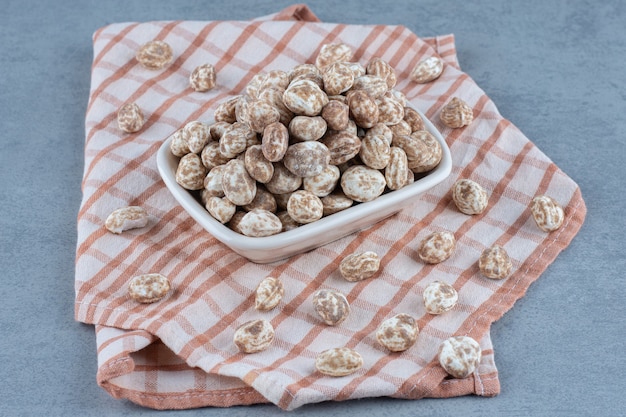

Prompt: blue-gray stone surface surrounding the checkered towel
[{"left": 0, "top": 0, "right": 626, "bottom": 417}]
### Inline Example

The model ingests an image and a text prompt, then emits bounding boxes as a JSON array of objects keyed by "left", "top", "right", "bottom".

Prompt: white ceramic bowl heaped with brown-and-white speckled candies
[{"left": 157, "top": 51, "right": 452, "bottom": 263}]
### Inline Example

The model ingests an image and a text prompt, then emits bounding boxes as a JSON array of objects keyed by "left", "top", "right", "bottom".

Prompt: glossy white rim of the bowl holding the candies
[{"left": 156, "top": 103, "right": 452, "bottom": 251}]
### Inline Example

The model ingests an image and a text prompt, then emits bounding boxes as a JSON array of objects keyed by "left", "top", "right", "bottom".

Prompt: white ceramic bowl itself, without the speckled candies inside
[{"left": 157, "top": 108, "right": 452, "bottom": 263}]
